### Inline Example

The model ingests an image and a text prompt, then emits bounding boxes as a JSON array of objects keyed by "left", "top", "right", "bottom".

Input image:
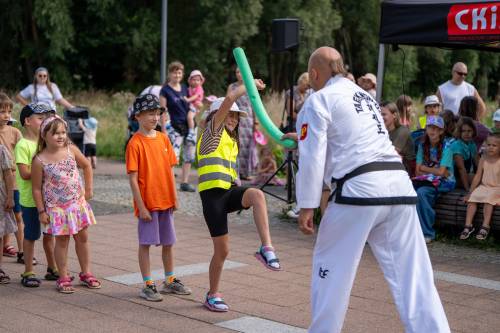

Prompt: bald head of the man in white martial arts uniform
[{"left": 309, "top": 46, "right": 346, "bottom": 90}]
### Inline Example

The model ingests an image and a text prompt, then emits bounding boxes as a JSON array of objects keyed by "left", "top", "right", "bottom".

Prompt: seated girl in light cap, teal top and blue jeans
[{"left": 413, "top": 116, "right": 455, "bottom": 243}]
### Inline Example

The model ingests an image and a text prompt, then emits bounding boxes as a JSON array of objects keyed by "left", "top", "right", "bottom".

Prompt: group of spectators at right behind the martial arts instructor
[{"left": 380, "top": 63, "right": 500, "bottom": 243}]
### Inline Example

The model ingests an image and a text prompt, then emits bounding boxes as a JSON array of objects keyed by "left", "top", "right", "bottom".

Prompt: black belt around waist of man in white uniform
[{"left": 328, "top": 162, "right": 417, "bottom": 206}]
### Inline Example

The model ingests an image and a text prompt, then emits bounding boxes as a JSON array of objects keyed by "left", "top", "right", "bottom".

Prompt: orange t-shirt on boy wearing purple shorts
[{"left": 125, "top": 132, "right": 177, "bottom": 216}]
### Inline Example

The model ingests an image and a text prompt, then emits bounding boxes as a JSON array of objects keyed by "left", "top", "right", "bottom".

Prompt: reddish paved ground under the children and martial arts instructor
[{"left": 0, "top": 161, "right": 500, "bottom": 333}]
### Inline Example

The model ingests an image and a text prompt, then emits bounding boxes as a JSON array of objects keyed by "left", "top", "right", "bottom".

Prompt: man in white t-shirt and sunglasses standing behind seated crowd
[{"left": 436, "top": 62, "right": 486, "bottom": 119}]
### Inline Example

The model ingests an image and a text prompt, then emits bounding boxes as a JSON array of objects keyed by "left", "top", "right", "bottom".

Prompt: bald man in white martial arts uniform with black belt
[{"left": 297, "top": 47, "right": 450, "bottom": 333}]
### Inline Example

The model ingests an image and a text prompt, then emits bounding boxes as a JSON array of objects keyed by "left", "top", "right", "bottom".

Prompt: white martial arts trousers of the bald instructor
[{"left": 309, "top": 202, "right": 450, "bottom": 333}]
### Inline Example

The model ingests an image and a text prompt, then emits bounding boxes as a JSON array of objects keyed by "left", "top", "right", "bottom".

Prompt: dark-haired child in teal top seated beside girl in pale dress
[{"left": 451, "top": 117, "right": 479, "bottom": 191}]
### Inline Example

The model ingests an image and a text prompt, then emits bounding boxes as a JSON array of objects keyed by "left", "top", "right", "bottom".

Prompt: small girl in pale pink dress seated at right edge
[{"left": 460, "top": 133, "right": 500, "bottom": 240}]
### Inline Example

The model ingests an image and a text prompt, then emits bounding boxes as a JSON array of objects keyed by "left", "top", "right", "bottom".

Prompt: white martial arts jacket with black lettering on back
[{"left": 296, "top": 75, "right": 416, "bottom": 208}]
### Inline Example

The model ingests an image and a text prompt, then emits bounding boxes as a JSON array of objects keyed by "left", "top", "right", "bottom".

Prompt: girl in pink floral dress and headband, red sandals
[{"left": 31, "top": 115, "right": 101, "bottom": 294}]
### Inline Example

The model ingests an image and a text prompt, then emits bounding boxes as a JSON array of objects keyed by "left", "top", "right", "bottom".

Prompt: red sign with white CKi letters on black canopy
[{"left": 448, "top": 2, "right": 500, "bottom": 36}]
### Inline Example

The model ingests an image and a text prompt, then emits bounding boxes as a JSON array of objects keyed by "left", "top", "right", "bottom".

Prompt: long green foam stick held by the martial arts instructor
[{"left": 233, "top": 47, "right": 297, "bottom": 149}]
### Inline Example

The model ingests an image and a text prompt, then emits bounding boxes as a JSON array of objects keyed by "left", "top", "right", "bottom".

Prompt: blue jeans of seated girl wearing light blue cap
[{"left": 416, "top": 186, "right": 439, "bottom": 239}]
